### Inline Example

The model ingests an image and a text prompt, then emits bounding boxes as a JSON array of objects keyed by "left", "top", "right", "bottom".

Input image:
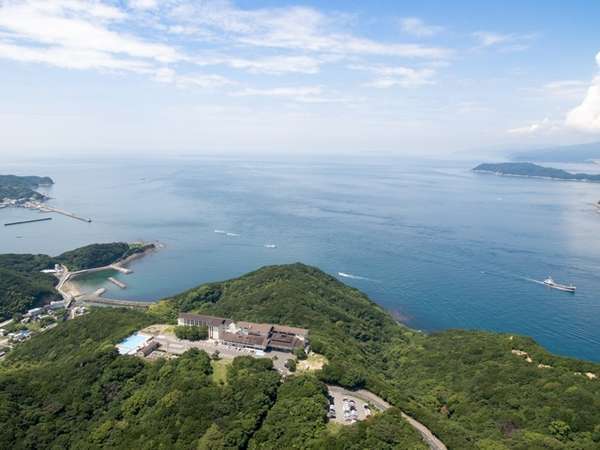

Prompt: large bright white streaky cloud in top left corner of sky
[{"left": 0, "top": 0, "right": 239, "bottom": 88}]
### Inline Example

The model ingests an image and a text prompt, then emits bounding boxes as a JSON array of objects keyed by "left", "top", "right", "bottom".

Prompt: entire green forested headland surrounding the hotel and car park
[{"left": 0, "top": 263, "right": 600, "bottom": 450}]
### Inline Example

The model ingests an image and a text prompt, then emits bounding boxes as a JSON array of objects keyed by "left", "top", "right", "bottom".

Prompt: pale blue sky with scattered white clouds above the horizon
[{"left": 0, "top": 0, "right": 600, "bottom": 157}]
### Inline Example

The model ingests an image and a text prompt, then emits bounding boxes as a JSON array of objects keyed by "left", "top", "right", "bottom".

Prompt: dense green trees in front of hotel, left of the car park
[{"left": 0, "top": 308, "right": 423, "bottom": 450}]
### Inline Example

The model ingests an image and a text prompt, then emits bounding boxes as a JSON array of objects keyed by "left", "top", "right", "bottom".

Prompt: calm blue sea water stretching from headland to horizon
[{"left": 0, "top": 158, "right": 600, "bottom": 361}]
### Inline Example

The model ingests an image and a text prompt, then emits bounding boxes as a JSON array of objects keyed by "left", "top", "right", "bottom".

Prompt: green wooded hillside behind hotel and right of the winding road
[{"left": 153, "top": 264, "right": 600, "bottom": 450}]
